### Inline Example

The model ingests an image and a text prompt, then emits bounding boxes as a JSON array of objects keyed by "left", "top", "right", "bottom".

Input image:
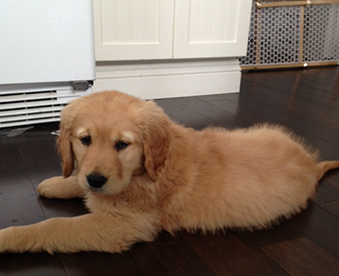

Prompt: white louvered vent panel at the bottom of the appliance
[{"left": 0, "top": 90, "right": 79, "bottom": 128}]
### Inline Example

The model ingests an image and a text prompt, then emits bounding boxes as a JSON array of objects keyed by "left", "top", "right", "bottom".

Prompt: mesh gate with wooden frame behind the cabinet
[{"left": 239, "top": 1, "right": 339, "bottom": 68}]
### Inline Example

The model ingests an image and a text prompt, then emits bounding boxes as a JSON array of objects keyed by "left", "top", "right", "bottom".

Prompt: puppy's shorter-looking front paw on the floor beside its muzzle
[{"left": 37, "top": 176, "right": 86, "bottom": 199}]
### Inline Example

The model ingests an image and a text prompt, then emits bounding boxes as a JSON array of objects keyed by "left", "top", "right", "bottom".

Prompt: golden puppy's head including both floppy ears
[{"left": 57, "top": 91, "right": 171, "bottom": 195}]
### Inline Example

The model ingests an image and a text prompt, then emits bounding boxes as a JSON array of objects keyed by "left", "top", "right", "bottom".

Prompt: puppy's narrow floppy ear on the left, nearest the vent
[{"left": 57, "top": 106, "right": 74, "bottom": 178}]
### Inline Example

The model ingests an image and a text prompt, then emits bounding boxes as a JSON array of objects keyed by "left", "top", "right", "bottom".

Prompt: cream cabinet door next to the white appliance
[{"left": 93, "top": 0, "right": 174, "bottom": 61}]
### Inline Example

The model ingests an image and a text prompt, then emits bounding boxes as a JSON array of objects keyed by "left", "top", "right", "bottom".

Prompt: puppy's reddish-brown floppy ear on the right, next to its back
[{"left": 143, "top": 102, "right": 171, "bottom": 182}]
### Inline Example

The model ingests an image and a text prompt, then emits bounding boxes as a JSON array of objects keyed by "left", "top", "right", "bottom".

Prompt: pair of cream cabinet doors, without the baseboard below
[{"left": 93, "top": 0, "right": 251, "bottom": 61}]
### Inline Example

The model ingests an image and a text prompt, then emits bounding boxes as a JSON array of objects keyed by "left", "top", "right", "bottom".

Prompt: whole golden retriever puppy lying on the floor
[{"left": 0, "top": 91, "right": 339, "bottom": 252}]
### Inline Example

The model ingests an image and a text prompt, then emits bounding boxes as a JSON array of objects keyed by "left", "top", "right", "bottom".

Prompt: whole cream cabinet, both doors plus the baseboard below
[{"left": 93, "top": 0, "right": 252, "bottom": 98}]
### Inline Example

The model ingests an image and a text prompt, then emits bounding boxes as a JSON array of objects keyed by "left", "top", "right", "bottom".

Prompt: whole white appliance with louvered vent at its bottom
[{"left": 0, "top": 0, "right": 95, "bottom": 128}]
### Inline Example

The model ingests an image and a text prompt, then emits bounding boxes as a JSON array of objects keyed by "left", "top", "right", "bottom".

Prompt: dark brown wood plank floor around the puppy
[{"left": 0, "top": 67, "right": 339, "bottom": 276}]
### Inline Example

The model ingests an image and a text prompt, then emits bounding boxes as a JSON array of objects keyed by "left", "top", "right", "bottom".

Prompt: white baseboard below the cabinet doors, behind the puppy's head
[{"left": 92, "top": 58, "right": 241, "bottom": 99}]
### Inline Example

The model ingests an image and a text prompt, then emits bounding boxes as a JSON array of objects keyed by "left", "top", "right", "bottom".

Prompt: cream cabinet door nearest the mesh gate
[{"left": 173, "top": 0, "right": 252, "bottom": 58}]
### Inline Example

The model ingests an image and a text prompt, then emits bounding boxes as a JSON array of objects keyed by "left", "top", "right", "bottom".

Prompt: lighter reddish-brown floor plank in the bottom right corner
[{"left": 262, "top": 237, "right": 339, "bottom": 276}]
